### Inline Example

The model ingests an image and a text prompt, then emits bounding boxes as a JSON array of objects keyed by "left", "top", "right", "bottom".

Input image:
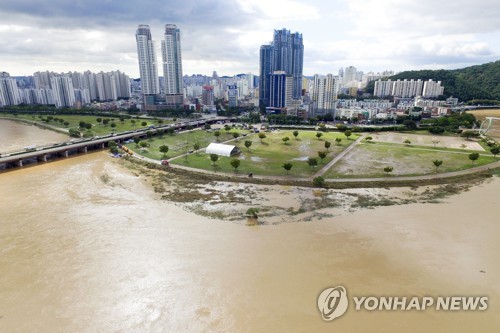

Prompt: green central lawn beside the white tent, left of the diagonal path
[{"left": 172, "top": 131, "right": 357, "bottom": 177}]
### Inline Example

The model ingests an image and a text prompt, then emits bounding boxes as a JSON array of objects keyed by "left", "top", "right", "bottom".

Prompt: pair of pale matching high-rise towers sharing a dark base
[{"left": 135, "top": 24, "right": 184, "bottom": 111}]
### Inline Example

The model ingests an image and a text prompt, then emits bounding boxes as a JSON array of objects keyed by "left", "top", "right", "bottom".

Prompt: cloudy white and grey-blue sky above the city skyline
[{"left": 0, "top": 0, "right": 500, "bottom": 77}]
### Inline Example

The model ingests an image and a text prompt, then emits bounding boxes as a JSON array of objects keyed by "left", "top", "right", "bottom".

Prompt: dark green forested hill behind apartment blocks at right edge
[{"left": 367, "top": 60, "right": 500, "bottom": 102}]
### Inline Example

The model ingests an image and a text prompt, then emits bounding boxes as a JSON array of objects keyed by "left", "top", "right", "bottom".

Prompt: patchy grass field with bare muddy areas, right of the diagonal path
[{"left": 325, "top": 143, "right": 495, "bottom": 178}]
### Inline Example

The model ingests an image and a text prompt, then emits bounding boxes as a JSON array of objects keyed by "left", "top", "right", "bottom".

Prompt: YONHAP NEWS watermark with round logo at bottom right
[{"left": 318, "top": 286, "right": 488, "bottom": 321}]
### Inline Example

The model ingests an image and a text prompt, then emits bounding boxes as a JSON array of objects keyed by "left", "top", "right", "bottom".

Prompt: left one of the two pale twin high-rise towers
[{"left": 135, "top": 24, "right": 160, "bottom": 95}]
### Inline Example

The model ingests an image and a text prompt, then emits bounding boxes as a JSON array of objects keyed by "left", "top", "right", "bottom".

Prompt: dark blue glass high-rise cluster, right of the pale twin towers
[{"left": 260, "top": 29, "right": 304, "bottom": 107}]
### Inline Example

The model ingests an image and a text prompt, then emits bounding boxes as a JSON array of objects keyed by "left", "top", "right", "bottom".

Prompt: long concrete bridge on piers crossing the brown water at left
[{"left": 0, "top": 117, "right": 233, "bottom": 171}]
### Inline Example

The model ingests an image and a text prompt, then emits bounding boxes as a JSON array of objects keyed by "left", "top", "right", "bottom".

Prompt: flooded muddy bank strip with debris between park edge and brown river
[{"left": 120, "top": 159, "right": 500, "bottom": 225}]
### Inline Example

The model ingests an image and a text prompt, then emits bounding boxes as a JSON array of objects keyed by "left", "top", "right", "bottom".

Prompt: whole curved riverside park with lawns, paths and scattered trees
[{"left": 126, "top": 125, "right": 497, "bottom": 179}]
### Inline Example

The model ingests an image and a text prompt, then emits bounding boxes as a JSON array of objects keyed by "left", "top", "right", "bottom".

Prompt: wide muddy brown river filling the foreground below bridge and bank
[{"left": 0, "top": 122, "right": 500, "bottom": 332}]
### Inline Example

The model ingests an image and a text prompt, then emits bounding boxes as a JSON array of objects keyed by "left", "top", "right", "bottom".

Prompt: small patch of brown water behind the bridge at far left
[{"left": 0, "top": 119, "right": 69, "bottom": 154}]
